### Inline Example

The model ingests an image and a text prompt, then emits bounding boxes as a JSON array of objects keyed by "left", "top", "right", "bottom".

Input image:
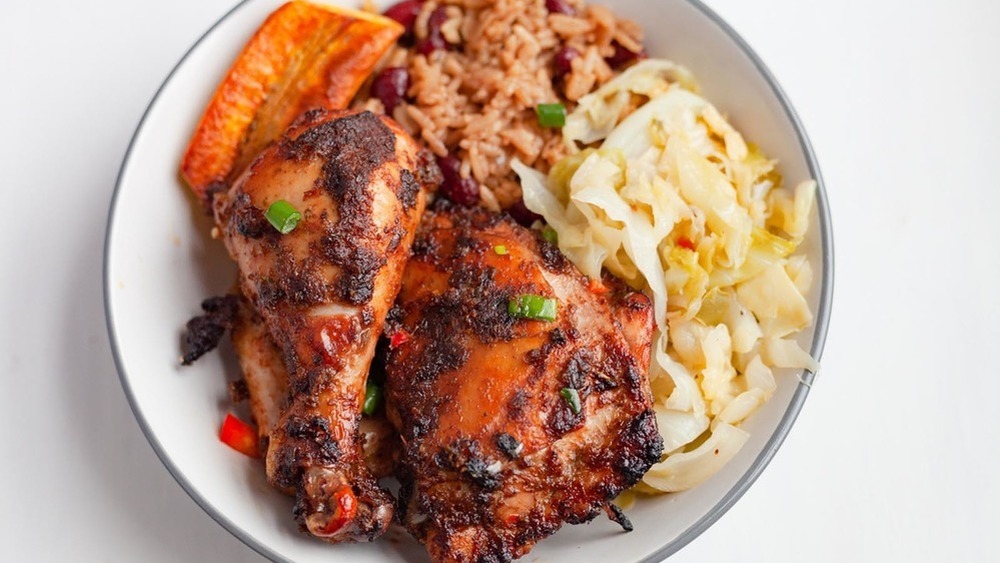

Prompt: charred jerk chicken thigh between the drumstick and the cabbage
[{"left": 385, "top": 202, "right": 663, "bottom": 562}]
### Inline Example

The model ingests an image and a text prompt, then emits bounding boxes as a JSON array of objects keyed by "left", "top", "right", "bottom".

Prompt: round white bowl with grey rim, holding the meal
[{"left": 104, "top": 0, "right": 833, "bottom": 563}]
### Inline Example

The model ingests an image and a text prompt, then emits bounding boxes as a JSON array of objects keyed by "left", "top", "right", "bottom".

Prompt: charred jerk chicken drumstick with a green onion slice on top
[{"left": 213, "top": 111, "right": 440, "bottom": 542}]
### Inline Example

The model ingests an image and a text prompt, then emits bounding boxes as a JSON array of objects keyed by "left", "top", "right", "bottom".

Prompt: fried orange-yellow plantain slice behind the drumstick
[{"left": 181, "top": 0, "right": 403, "bottom": 202}]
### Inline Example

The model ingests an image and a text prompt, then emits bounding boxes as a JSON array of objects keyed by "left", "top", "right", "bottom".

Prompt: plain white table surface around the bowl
[{"left": 0, "top": 0, "right": 1000, "bottom": 562}]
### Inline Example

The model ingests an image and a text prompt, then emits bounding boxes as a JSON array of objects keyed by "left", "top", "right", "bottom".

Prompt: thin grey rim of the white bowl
[{"left": 102, "top": 0, "right": 834, "bottom": 563}]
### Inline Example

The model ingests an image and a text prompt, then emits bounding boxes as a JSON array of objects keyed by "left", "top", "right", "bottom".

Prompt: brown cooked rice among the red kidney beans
[{"left": 360, "top": 0, "right": 642, "bottom": 208}]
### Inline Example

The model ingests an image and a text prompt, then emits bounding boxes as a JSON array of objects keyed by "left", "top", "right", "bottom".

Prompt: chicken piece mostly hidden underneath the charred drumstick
[{"left": 232, "top": 296, "right": 399, "bottom": 478}]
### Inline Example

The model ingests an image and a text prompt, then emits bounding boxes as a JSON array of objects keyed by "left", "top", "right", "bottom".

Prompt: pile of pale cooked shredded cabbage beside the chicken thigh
[{"left": 513, "top": 59, "right": 819, "bottom": 492}]
